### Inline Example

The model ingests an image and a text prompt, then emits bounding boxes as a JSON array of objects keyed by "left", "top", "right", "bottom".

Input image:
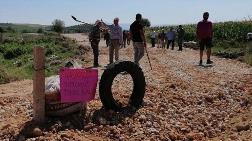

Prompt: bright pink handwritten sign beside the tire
[{"left": 60, "top": 68, "right": 98, "bottom": 103}]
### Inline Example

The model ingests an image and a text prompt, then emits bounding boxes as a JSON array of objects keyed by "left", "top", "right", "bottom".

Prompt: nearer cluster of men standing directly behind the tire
[{"left": 89, "top": 14, "right": 146, "bottom": 67}]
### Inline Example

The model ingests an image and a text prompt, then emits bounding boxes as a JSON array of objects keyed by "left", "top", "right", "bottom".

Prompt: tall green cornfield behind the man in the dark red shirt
[{"left": 146, "top": 20, "right": 252, "bottom": 65}]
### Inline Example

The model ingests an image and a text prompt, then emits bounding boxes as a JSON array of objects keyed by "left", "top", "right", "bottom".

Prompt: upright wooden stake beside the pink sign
[{"left": 33, "top": 46, "right": 45, "bottom": 123}]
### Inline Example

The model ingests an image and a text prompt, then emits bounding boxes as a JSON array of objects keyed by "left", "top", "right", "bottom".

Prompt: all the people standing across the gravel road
[{"left": 89, "top": 12, "right": 213, "bottom": 67}]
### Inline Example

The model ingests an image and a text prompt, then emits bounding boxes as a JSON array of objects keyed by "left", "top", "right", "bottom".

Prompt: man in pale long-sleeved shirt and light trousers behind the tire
[{"left": 109, "top": 18, "right": 123, "bottom": 64}]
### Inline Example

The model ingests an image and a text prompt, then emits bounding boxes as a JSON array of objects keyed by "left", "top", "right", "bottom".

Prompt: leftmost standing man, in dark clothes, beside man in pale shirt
[{"left": 89, "top": 20, "right": 102, "bottom": 67}]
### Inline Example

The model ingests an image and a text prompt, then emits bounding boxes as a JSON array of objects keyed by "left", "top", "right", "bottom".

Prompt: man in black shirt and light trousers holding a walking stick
[{"left": 130, "top": 14, "right": 146, "bottom": 65}]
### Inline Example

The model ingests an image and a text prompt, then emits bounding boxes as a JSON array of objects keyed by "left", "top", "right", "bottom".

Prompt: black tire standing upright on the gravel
[{"left": 99, "top": 61, "right": 146, "bottom": 111}]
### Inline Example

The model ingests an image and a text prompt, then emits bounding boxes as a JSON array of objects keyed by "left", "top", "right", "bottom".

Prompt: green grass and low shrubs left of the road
[{"left": 0, "top": 22, "right": 83, "bottom": 84}]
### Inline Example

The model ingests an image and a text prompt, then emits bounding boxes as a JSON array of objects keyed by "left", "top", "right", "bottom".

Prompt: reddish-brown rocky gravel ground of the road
[{"left": 0, "top": 34, "right": 252, "bottom": 141}]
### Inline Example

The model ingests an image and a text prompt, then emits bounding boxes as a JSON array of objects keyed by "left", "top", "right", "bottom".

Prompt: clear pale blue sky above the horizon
[{"left": 0, "top": 0, "right": 252, "bottom": 26}]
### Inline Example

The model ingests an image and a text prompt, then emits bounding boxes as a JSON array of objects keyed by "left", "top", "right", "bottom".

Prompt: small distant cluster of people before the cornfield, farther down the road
[{"left": 150, "top": 25, "right": 185, "bottom": 51}]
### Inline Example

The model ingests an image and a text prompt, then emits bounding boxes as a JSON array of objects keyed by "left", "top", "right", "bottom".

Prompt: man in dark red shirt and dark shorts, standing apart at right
[{"left": 197, "top": 12, "right": 213, "bottom": 65}]
